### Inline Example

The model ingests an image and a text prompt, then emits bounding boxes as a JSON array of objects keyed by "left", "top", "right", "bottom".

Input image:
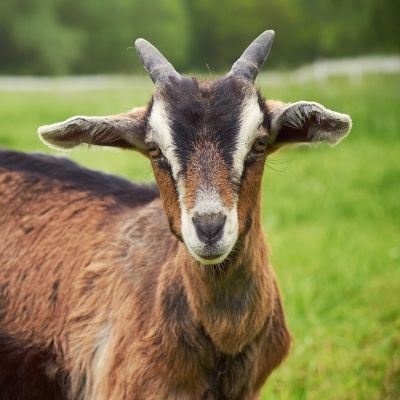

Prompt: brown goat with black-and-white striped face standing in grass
[{"left": 0, "top": 31, "right": 351, "bottom": 400}]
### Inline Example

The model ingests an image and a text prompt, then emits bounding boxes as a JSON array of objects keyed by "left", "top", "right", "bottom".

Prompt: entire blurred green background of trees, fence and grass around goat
[{"left": 0, "top": 0, "right": 400, "bottom": 400}]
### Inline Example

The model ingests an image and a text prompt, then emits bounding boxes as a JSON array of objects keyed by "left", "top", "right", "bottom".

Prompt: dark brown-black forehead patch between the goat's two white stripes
[{"left": 161, "top": 78, "right": 247, "bottom": 172}]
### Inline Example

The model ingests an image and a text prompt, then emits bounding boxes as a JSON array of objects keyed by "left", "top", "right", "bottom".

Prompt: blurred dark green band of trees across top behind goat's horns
[{"left": 0, "top": 0, "right": 400, "bottom": 74}]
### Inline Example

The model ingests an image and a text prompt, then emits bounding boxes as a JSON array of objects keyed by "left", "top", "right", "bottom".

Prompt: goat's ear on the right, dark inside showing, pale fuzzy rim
[{"left": 267, "top": 101, "right": 351, "bottom": 153}]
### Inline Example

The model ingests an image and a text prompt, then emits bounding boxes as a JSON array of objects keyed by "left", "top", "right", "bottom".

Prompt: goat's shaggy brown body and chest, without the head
[{"left": 0, "top": 151, "right": 289, "bottom": 400}]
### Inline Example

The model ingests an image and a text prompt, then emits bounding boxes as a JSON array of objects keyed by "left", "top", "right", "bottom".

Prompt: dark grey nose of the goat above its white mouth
[{"left": 192, "top": 213, "right": 226, "bottom": 244}]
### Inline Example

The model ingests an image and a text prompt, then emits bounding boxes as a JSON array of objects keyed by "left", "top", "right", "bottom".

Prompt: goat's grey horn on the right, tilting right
[{"left": 228, "top": 30, "right": 275, "bottom": 81}]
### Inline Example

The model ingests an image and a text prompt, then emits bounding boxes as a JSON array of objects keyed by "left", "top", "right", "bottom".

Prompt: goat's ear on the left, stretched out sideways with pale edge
[{"left": 38, "top": 107, "right": 147, "bottom": 153}]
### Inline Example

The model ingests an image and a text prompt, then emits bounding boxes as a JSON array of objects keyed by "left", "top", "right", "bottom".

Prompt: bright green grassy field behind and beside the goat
[{"left": 0, "top": 75, "right": 400, "bottom": 400}]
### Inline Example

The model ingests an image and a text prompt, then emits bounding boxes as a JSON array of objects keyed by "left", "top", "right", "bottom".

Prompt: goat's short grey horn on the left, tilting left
[{"left": 135, "top": 39, "right": 180, "bottom": 84}]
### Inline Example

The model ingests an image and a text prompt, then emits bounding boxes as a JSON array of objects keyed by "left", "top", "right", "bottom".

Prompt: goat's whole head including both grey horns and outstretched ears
[{"left": 39, "top": 31, "right": 351, "bottom": 264}]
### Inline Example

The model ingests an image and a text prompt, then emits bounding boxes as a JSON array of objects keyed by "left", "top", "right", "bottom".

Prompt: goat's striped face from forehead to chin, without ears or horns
[{"left": 145, "top": 76, "right": 269, "bottom": 264}]
